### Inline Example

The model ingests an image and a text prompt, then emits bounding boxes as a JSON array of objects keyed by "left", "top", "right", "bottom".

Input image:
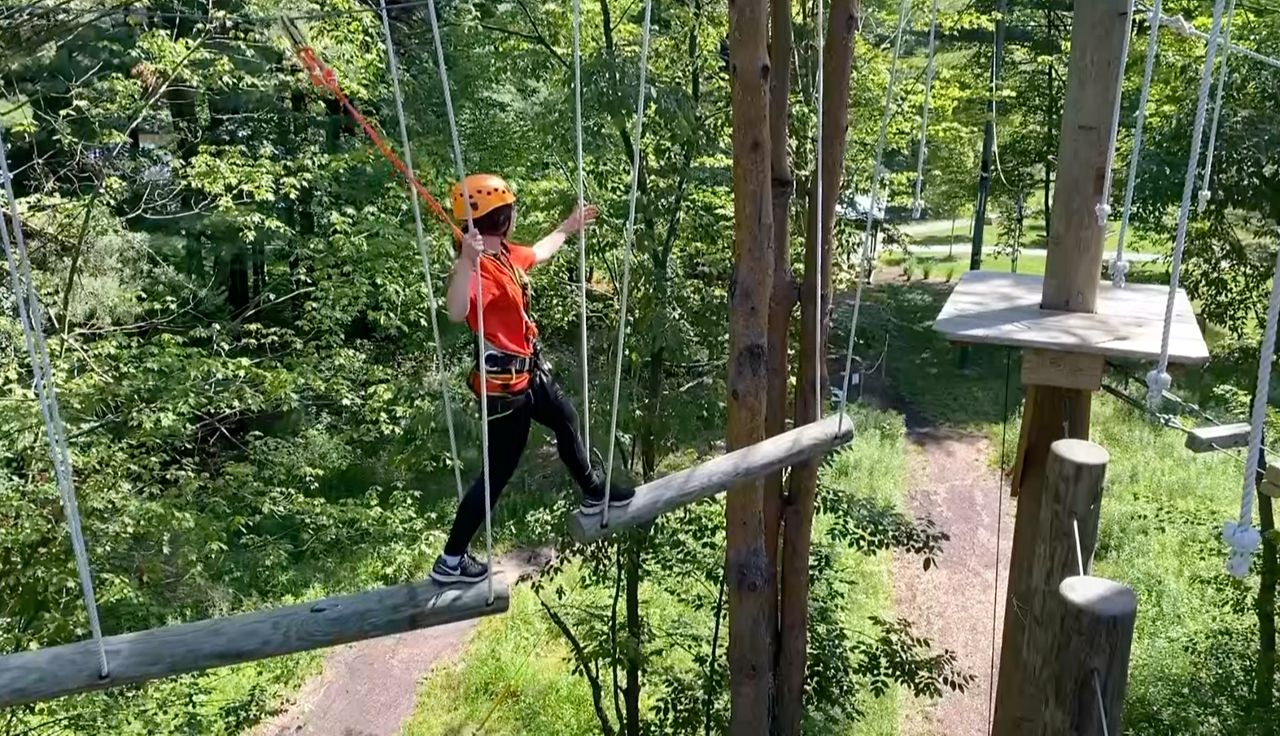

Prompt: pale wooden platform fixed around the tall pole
[{"left": 933, "top": 271, "right": 1208, "bottom": 365}]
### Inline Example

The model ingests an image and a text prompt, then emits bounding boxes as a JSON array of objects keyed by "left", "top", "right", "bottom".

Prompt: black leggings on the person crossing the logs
[{"left": 444, "top": 371, "right": 591, "bottom": 556}]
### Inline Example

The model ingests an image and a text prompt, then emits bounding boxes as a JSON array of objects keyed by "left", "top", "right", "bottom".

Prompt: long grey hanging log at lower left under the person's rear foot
[{"left": 0, "top": 582, "right": 509, "bottom": 708}]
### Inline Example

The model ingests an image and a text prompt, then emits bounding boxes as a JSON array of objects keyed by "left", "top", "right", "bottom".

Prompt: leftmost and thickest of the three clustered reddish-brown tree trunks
[{"left": 724, "top": 0, "right": 773, "bottom": 736}]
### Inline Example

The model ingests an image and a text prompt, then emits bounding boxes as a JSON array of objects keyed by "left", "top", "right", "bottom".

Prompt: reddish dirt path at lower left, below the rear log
[{"left": 250, "top": 549, "right": 552, "bottom": 736}]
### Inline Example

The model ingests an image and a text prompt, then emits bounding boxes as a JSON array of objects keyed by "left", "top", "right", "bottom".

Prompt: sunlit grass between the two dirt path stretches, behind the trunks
[{"left": 404, "top": 407, "right": 908, "bottom": 736}]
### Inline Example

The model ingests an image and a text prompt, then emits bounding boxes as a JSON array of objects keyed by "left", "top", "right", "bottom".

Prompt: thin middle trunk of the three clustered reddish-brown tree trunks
[{"left": 764, "top": 0, "right": 796, "bottom": 675}]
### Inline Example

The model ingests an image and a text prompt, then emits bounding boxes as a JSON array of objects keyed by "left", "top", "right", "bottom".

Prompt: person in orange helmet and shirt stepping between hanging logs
[{"left": 431, "top": 174, "right": 635, "bottom": 582}]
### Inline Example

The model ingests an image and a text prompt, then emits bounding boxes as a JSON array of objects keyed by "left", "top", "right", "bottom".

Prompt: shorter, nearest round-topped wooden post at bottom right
[{"left": 1054, "top": 575, "right": 1138, "bottom": 736}]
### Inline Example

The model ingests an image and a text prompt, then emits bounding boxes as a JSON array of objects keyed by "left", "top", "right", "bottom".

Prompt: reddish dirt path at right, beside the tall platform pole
[{"left": 893, "top": 419, "right": 1014, "bottom": 736}]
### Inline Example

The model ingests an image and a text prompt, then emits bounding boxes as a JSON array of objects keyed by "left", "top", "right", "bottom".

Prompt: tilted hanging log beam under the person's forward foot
[{"left": 568, "top": 415, "right": 854, "bottom": 544}]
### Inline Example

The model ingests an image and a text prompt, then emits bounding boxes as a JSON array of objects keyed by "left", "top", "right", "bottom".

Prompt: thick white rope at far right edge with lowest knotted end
[{"left": 1222, "top": 239, "right": 1280, "bottom": 577}]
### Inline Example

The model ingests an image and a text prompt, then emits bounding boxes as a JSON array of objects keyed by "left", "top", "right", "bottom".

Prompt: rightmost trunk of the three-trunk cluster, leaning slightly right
[{"left": 774, "top": 0, "right": 858, "bottom": 736}]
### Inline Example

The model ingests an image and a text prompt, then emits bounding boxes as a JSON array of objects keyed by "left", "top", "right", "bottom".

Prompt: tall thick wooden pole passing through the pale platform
[{"left": 995, "top": 0, "right": 1129, "bottom": 736}]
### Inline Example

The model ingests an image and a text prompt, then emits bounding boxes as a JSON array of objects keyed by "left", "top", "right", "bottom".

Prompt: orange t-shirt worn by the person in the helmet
[{"left": 467, "top": 243, "right": 538, "bottom": 393}]
